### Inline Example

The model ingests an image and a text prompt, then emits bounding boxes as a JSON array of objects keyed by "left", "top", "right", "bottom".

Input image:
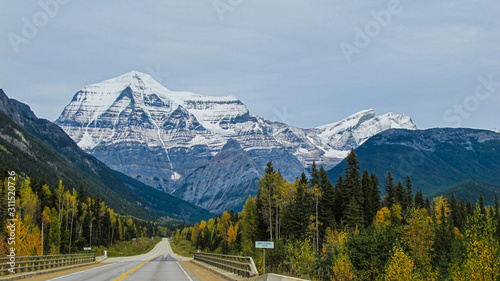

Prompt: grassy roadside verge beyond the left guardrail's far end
[{"left": 93, "top": 236, "right": 162, "bottom": 257}]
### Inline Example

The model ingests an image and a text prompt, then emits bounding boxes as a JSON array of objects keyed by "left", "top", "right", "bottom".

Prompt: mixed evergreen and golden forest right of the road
[{"left": 174, "top": 151, "right": 500, "bottom": 280}]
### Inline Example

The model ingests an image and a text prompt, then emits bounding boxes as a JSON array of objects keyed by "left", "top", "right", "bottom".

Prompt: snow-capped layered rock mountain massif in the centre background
[{"left": 56, "top": 71, "right": 415, "bottom": 211}]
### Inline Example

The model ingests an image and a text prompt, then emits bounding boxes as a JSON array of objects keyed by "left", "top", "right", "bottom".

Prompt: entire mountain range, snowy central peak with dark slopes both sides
[{"left": 0, "top": 71, "right": 500, "bottom": 213}]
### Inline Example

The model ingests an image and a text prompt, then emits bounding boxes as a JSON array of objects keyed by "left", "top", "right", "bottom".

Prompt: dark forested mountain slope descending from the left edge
[{"left": 0, "top": 89, "right": 212, "bottom": 222}]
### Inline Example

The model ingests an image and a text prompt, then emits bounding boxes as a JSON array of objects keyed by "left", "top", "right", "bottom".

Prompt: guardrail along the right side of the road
[{"left": 194, "top": 250, "right": 259, "bottom": 277}]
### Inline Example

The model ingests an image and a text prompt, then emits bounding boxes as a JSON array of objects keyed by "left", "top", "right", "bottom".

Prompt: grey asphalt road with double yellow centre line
[{"left": 50, "top": 239, "right": 199, "bottom": 281}]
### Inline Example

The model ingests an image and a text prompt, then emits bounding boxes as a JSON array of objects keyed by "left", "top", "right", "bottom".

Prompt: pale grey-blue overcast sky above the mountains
[{"left": 0, "top": 0, "right": 500, "bottom": 129}]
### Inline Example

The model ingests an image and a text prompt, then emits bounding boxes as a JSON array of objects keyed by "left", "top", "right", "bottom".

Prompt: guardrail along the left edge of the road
[{"left": 0, "top": 254, "right": 95, "bottom": 276}]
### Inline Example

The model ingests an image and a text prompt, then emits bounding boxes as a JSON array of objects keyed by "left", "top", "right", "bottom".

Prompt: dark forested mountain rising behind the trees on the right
[{"left": 328, "top": 128, "right": 500, "bottom": 199}]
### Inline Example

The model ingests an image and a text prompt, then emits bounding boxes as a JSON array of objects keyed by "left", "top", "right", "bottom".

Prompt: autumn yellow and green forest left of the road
[{"left": 0, "top": 167, "right": 169, "bottom": 256}]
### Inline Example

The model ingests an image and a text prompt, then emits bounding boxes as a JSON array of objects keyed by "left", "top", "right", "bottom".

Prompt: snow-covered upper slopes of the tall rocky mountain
[{"left": 56, "top": 71, "right": 416, "bottom": 170}]
